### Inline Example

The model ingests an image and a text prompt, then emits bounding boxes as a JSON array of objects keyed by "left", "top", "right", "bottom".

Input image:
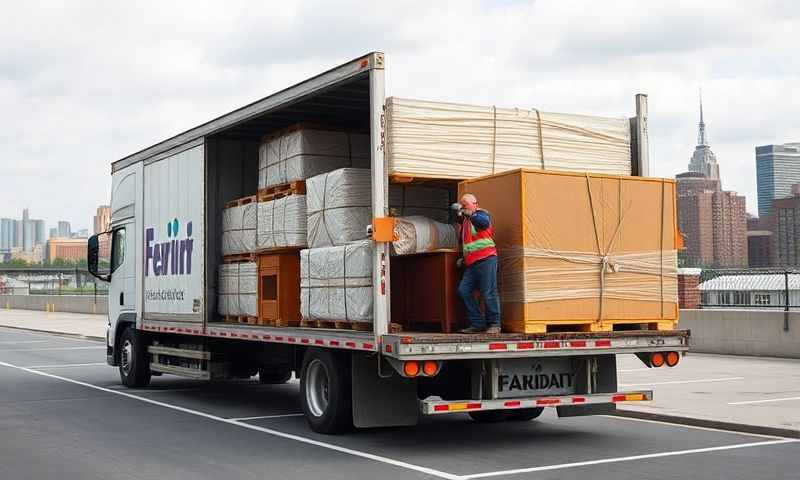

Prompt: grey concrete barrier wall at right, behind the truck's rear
[{"left": 678, "top": 309, "right": 800, "bottom": 358}]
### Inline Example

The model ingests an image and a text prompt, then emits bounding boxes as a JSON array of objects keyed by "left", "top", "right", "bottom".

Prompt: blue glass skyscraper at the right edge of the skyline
[{"left": 756, "top": 142, "right": 800, "bottom": 218}]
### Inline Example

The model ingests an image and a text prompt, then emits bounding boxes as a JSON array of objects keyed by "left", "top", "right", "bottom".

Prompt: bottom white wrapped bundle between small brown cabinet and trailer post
[{"left": 300, "top": 240, "right": 372, "bottom": 322}]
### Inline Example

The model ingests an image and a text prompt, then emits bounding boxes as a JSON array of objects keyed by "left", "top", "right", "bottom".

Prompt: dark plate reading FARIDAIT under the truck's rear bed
[{"left": 492, "top": 357, "right": 575, "bottom": 398}]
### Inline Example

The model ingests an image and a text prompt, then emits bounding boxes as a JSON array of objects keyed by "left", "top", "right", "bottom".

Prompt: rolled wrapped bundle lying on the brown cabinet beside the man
[{"left": 392, "top": 216, "right": 458, "bottom": 255}]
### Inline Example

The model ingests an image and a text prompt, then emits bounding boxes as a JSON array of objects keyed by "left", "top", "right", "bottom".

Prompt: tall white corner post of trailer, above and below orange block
[{"left": 369, "top": 52, "right": 390, "bottom": 338}]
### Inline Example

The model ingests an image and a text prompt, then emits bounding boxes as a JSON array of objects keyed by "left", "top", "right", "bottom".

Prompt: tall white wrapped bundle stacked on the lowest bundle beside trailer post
[{"left": 306, "top": 168, "right": 372, "bottom": 248}]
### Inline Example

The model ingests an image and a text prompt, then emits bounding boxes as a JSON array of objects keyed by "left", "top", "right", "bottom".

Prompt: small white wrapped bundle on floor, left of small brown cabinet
[{"left": 218, "top": 262, "right": 258, "bottom": 317}]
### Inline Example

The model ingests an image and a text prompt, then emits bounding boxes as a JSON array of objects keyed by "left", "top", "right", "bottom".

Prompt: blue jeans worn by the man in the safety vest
[{"left": 458, "top": 256, "right": 500, "bottom": 329}]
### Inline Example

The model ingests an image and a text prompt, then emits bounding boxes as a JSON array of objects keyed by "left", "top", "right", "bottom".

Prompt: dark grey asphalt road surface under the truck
[{"left": 0, "top": 328, "right": 800, "bottom": 480}]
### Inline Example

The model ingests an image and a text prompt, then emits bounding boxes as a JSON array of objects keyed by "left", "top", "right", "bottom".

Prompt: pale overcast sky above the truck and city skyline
[{"left": 0, "top": 0, "right": 800, "bottom": 229}]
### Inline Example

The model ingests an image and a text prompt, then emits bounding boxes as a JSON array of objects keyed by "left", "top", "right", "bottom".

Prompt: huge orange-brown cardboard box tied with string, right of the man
[{"left": 459, "top": 169, "right": 678, "bottom": 333}]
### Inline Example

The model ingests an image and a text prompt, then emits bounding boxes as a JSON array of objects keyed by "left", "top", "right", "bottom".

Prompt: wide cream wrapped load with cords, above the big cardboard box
[{"left": 386, "top": 97, "right": 631, "bottom": 179}]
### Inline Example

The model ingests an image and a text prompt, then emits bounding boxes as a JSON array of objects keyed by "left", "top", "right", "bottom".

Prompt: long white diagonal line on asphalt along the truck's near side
[{"left": 0, "top": 362, "right": 464, "bottom": 480}]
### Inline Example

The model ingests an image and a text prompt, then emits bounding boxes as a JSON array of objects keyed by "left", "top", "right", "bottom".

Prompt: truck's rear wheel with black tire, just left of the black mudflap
[{"left": 300, "top": 348, "right": 353, "bottom": 434}]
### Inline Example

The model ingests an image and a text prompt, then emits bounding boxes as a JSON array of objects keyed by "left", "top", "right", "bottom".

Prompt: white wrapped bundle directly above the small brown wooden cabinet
[{"left": 258, "top": 195, "right": 307, "bottom": 248}]
